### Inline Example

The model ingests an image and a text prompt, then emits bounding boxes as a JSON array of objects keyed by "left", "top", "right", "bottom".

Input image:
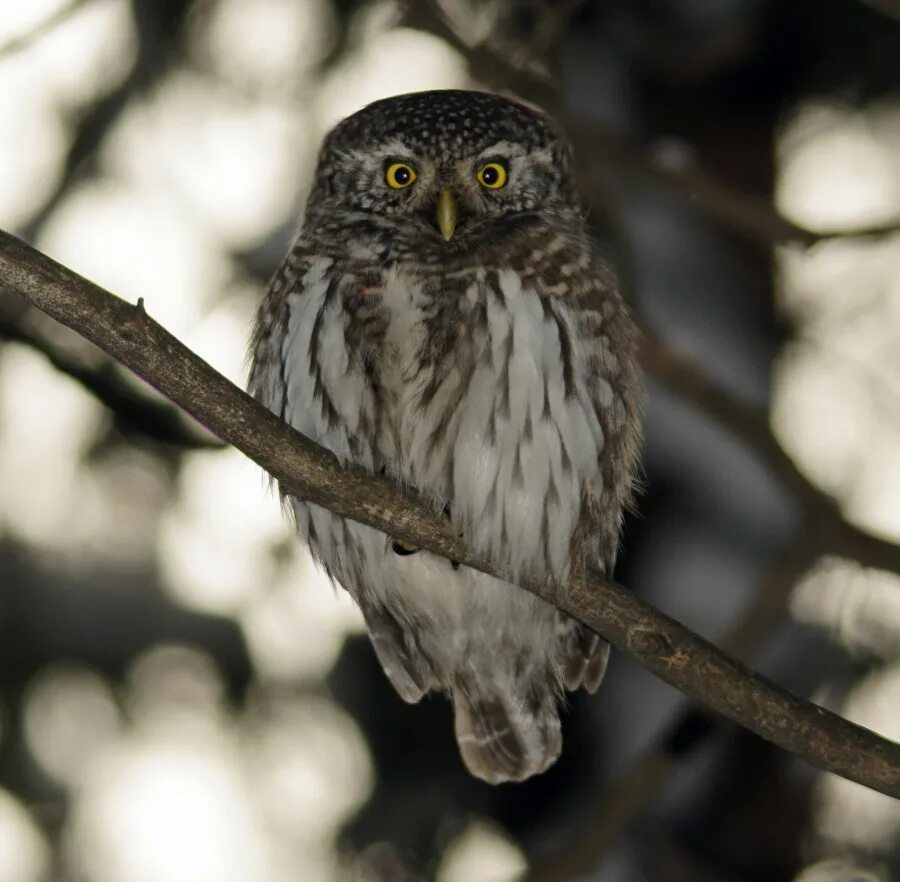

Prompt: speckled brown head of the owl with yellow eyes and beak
[{"left": 308, "top": 90, "right": 577, "bottom": 241}]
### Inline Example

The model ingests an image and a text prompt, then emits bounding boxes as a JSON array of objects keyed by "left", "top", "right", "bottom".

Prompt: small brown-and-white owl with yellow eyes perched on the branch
[{"left": 250, "top": 91, "right": 641, "bottom": 784}]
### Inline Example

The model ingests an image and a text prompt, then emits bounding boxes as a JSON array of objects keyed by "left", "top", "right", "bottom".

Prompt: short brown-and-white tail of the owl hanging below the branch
[{"left": 453, "top": 684, "right": 562, "bottom": 784}]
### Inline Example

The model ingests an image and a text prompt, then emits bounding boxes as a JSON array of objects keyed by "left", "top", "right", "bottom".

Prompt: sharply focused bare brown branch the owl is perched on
[{"left": 0, "top": 232, "right": 900, "bottom": 797}]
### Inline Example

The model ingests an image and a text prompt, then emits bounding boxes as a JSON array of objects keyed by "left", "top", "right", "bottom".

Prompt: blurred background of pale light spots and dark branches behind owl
[{"left": 0, "top": 0, "right": 900, "bottom": 882}]
